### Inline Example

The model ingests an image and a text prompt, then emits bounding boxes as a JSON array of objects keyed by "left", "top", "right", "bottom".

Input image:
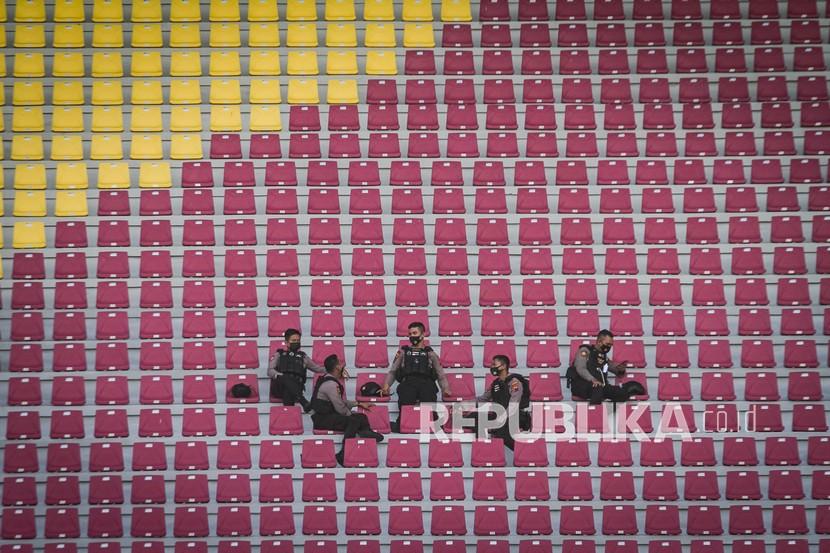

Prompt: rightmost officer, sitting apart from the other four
[{"left": 565, "top": 330, "right": 631, "bottom": 405}]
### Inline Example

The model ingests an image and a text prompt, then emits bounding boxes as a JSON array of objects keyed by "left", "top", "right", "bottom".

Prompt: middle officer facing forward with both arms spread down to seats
[{"left": 381, "top": 322, "right": 450, "bottom": 432}]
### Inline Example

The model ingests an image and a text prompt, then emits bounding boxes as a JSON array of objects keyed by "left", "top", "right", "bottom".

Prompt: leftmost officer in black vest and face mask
[{"left": 268, "top": 328, "right": 324, "bottom": 413}]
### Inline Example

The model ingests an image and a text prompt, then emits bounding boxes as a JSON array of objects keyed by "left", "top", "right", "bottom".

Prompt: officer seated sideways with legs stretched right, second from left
[{"left": 311, "top": 354, "right": 383, "bottom": 466}]
